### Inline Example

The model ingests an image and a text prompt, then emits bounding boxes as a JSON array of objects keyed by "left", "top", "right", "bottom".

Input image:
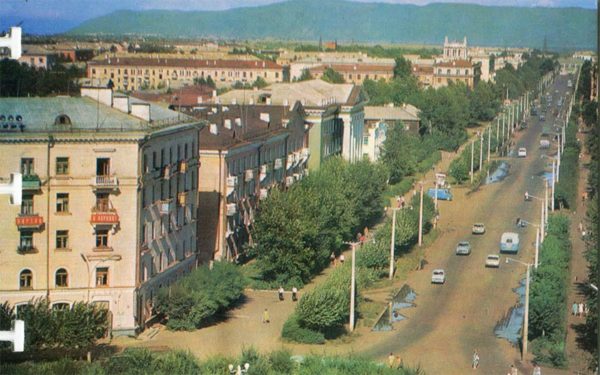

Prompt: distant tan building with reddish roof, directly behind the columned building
[{"left": 309, "top": 64, "right": 394, "bottom": 85}]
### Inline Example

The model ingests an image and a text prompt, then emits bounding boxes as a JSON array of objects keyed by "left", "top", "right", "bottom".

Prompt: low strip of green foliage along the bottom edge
[{"left": 0, "top": 348, "right": 422, "bottom": 375}]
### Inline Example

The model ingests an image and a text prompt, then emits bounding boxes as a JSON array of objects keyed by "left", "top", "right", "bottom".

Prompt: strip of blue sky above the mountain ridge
[{"left": 0, "top": 0, "right": 596, "bottom": 34}]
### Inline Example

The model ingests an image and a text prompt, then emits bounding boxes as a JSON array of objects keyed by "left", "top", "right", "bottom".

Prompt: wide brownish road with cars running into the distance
[{"left": 363, "top": 76, "right": 574, "bottom": 375}]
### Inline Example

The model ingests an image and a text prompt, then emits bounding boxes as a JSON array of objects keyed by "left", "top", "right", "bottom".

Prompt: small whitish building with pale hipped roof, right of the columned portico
[{"left": 363, "top": 104, "right": 420, "bottom": 161}]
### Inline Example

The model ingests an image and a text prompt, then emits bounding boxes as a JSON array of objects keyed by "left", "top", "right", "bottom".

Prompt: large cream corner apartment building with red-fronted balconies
[{"left": 0, "top": 88, "right": 200, "bottom": 334}]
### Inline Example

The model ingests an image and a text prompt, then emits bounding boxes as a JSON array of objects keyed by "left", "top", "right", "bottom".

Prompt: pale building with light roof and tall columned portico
[{"left": 216, "top": 79, "right": 367, "bottom": 170}]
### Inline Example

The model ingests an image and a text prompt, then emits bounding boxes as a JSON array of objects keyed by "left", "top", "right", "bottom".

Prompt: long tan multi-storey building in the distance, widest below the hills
[{"left": 87, "top": 57, "right": 283, "bottom": 91}]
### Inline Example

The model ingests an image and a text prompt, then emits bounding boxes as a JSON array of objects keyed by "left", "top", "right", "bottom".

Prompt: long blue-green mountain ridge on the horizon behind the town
[{"left": 67, "top": 0, "right": 597, "bottom": 50}]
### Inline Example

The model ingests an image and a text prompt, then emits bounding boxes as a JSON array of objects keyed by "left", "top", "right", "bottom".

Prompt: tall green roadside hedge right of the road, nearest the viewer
[{"left": 529, "top": 215, "right": 571, "bottom": 366}]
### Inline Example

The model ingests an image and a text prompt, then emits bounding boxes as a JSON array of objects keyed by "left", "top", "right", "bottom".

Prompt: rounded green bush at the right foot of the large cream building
[{"left": 157, "top": 262, "right": 246, "bottom": 330}]
